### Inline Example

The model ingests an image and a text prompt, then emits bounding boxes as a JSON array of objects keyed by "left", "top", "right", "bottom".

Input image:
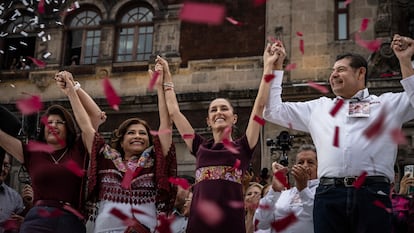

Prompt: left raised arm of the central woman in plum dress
[{"left": 157, "top": 56, "right": 194, "bottom": 150}]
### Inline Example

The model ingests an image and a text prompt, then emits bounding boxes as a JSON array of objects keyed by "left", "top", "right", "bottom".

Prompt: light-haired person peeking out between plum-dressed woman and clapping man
[{"left": 244, "top": 182, "right": 263, "bottom": 233}]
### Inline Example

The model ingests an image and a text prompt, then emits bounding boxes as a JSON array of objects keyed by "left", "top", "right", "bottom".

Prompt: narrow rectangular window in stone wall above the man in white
[{"left": 335, "top": 0, "right": 349, "bottom": 40}]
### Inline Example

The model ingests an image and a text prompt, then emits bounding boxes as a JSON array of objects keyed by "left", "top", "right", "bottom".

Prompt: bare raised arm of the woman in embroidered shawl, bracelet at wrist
[{"left": 148, "top": 63, "right": 172, "bottom": 156}]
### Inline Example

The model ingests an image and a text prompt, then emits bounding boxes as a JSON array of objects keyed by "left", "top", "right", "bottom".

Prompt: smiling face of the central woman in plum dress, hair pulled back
[{"left": 207, "top": 98, "right": 237, "bottom": 132}]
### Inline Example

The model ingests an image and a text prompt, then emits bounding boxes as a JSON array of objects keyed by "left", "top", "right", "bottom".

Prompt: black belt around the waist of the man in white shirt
[{"left": 319, "top": 176, "right": 390, "bottom": 187}]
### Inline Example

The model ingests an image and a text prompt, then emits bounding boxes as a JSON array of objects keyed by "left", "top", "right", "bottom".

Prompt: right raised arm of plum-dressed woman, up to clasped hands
[{"left": 246, "top": 42, "right": 286, "bottom": 148}]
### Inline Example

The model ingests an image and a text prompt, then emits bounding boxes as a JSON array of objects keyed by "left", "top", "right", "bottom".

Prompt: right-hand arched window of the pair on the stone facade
[{"left": 116, "top": 6, "right": 154, "bottom": 62}]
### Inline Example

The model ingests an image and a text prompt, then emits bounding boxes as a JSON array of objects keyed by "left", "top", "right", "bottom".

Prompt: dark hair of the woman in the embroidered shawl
[{"left": 111, "top": 118, "right": 153, "bottom": 156}]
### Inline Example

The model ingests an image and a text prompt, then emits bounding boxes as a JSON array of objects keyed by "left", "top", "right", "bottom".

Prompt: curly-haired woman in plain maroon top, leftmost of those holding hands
[{"left": 0, "top": 73, "right": 103, "bottom": 233}]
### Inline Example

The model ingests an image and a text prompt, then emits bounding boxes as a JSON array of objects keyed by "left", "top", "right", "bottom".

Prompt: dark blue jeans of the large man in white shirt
[{"left": 313, "top": 183, "right": 392, "bottom": 233}]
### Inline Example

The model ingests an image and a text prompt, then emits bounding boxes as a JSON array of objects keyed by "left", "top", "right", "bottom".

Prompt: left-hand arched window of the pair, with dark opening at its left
[{"left": 65, "top": 10, "right": 101, "bottom": 65}]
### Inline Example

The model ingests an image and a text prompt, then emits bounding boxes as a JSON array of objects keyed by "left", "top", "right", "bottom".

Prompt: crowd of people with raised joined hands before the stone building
[{"left": 0, "top": 35, "right": 414, "bottom": 233}]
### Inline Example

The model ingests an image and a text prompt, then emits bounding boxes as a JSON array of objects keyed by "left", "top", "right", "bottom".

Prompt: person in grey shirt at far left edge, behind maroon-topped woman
[{"left": 0, "top": 153, "right": 24, "bottom": 233}]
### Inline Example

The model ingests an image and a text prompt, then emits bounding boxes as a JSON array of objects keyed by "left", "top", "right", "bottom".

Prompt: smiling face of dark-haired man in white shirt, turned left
[{"left": 329, "top": 58, "right": 366, "bottom": 99}]
